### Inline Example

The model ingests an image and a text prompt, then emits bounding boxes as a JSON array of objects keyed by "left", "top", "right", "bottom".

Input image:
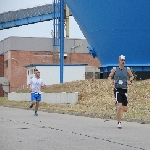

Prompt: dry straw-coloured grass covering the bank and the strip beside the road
[{"left": 0, "top": 79, "right": 150, "bottom": 120}]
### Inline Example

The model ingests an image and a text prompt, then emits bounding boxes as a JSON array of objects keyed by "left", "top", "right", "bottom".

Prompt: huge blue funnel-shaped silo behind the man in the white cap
[{"left": 65, "top": 0, "right": 150, "bottom": 79}]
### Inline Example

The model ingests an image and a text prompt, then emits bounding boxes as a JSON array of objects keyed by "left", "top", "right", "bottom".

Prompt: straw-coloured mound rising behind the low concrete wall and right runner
[{"left": 20, "top": 79, "right": 150, "bottom": 120}]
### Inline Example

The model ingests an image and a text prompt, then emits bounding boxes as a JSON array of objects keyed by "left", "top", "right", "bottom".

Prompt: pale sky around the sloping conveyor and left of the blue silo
[{"left": 0, "top": 0, "right": 85, "bottom": 41}]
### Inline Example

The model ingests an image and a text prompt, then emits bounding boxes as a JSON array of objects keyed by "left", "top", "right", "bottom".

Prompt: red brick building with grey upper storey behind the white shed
[{"left": 0, "top": 37, "right": 100, "bottom": 96}]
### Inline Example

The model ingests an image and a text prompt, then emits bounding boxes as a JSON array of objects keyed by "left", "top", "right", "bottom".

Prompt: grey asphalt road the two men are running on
[{"left": 0, "top": 107, "right": 150, "bottom": 150}]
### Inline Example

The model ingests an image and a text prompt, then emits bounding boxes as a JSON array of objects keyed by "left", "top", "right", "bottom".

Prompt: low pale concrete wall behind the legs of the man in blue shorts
[{"left": 8, "top": 92, "right": 78, "bottom": 104}]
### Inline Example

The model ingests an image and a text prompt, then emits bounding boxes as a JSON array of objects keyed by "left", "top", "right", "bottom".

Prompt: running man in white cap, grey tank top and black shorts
[{"left": 108, "top": 55, "right": 134, "bottom": 128}]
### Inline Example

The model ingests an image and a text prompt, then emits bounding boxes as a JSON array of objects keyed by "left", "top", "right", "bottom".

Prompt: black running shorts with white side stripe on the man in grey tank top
[{"left": 114, "top": 88, "right": 128, "bottom": 106}]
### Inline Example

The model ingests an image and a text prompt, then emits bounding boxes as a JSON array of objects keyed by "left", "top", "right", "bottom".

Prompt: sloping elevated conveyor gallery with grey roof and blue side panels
[{"left": 0, "top": 4, "right": 60, "bottom": 30}]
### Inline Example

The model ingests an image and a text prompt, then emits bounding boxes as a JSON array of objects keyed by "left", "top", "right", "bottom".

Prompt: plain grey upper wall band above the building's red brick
[{"left": 0, "top": 37, "right": 89, "bottom": 54}]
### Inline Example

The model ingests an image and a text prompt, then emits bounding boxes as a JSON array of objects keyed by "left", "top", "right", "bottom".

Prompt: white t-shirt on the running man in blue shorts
[{"left": 30, "top": 77, "right": 44, "bottom": 93}]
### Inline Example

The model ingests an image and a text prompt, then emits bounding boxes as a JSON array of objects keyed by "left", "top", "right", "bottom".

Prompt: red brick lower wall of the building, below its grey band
[{"left": 4, "top": 50, "right": 100, "bottom": 92}]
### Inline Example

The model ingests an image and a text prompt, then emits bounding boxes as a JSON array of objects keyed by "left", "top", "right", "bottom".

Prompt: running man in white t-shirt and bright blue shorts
[{"left": 29, "top": 69, "right": 45, "bottom": 116}]
